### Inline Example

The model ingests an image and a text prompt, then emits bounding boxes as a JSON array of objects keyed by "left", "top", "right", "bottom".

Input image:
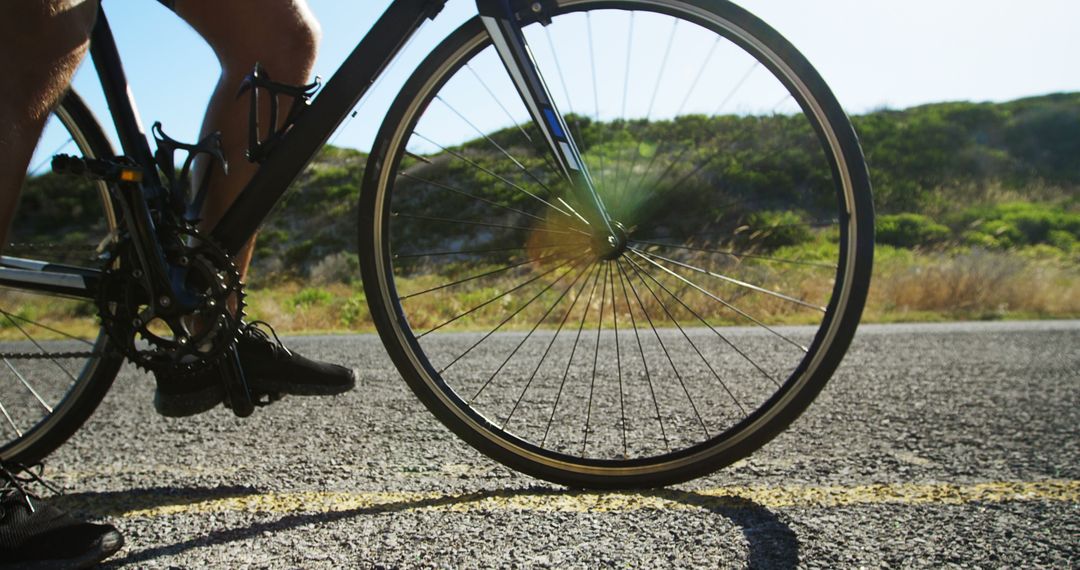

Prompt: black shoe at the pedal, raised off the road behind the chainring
[{"left": 153, "top": 321, "right": 356, "bottom": 418}]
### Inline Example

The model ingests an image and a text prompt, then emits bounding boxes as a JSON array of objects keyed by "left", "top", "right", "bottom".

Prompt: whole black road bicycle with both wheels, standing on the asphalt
[{"left": 0, "top": 0, "right": 874, "bottom": 488}]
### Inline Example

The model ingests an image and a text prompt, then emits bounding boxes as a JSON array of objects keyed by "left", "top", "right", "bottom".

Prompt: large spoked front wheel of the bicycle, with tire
[{"left": 361, "top": 0, "right": 873, "bottom": 487}]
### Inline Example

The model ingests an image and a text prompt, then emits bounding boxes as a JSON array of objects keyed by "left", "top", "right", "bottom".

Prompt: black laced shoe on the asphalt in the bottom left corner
[{"left": 0, "top": 466, "right": 124, "bottom": 570}]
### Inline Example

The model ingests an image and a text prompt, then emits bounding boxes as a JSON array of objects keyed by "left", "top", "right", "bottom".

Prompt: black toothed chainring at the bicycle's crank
[{"left": 97, "top": 226, "right": 244, "bottom": 376}]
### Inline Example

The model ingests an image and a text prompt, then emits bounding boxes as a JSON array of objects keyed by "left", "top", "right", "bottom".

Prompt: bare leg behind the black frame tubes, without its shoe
[{"left": 176, "top": 0, "right": 320, "bottom": 275}]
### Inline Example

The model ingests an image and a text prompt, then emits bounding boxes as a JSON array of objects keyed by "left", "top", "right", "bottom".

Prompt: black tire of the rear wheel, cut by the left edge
[{"left": 0, "top": 90, "right": 123, "bottom": 465}]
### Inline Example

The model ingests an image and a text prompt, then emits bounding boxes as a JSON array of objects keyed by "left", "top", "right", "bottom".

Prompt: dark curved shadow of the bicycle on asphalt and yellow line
[{"left": 59, "top": 487, "right": 799, "bottom": 569}]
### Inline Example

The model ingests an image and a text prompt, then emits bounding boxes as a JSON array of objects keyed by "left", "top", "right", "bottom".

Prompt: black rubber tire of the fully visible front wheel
[{"left": 360, "top": 0, "right": 874, "bottom": 488}]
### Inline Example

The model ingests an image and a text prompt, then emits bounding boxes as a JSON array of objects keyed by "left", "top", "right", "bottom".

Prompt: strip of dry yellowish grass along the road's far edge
[{"left": 0, "top": 247, "right": 1080, "bottom": 340}]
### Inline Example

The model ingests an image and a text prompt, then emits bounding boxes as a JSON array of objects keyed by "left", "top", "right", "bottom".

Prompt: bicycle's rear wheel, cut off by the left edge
[{"left": 0, "top": 87, "right": 123, "bottom": 464}]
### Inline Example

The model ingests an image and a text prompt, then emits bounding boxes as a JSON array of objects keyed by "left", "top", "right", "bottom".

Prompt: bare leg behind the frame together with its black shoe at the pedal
[{"left": 154, "top": 0, "right": 355, "bottom": 416}]
